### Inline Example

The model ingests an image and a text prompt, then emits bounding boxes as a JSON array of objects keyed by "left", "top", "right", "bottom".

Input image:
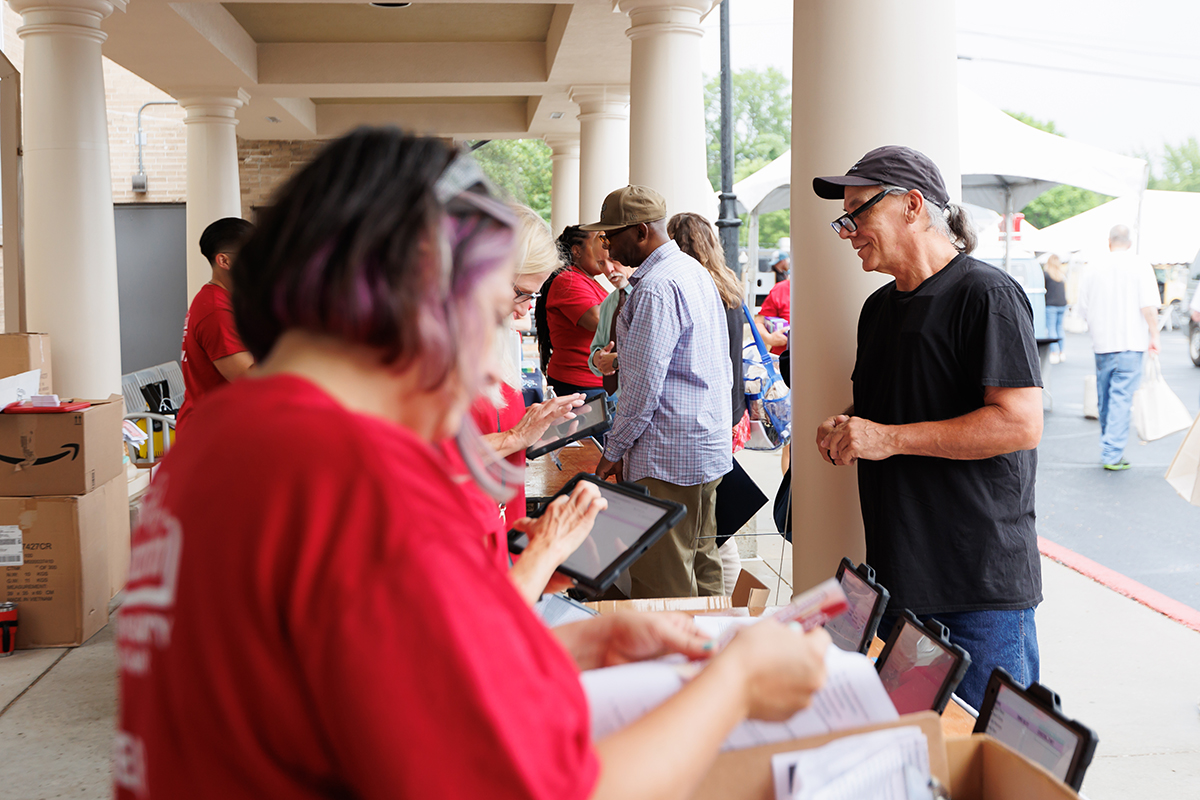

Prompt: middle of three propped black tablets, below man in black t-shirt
[{"left": 875, "top": 609, "right": 971, "bottom": 714}]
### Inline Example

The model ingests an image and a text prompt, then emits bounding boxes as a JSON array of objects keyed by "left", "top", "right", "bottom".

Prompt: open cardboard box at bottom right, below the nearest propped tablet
[{"left": 946, "top": 733, "right": 1079, "bottom": 800}]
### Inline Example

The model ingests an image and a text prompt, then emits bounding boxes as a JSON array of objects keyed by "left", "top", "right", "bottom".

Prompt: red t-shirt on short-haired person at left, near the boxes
[{"left": 176, "top": 283, "right": 246, "bottom": 428}]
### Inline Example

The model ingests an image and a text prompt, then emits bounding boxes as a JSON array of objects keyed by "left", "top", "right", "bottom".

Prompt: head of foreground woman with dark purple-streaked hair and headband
[{"left": 232, "top": 127, "right": 515, "bottom": 400}]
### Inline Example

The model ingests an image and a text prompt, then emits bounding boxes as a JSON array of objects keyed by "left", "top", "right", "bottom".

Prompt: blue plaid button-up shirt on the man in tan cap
[{"left": 605, "top": 241, "right": 733, "bottom": 486}]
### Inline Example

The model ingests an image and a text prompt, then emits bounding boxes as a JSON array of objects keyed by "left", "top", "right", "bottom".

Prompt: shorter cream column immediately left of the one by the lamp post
[{"left": 571, "top": 86, "right": 629, "bottom": 222}]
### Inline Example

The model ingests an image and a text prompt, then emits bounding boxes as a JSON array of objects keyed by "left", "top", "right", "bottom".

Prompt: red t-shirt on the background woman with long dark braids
[{"left": 546, "top": 267, "right": 608, "bottom": 389}]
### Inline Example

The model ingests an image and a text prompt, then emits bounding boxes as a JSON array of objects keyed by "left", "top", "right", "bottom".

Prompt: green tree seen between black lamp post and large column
[{"left": 704, "top": 67, "right": 792, "bottom": 247}]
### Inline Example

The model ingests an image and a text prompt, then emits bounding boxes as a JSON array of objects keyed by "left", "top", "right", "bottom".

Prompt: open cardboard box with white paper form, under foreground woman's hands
[{"left": 695, "top": 711, "right": 950, "bottom": 800}]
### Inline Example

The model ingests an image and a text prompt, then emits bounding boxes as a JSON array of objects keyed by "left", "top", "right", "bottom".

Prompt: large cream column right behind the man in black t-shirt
[{"left": 792, "top": 0, "right": 961, "bottom": 590}]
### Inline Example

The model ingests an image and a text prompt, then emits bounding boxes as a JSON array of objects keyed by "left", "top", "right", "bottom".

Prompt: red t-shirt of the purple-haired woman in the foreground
[{"left": 113, "top": 375, "right": 599, "bottom": 800}]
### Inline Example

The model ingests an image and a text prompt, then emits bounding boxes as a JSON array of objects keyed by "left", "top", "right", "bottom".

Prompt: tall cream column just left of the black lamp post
[{"left": 618, "top": 0, "right": 716, "bottom": 219}]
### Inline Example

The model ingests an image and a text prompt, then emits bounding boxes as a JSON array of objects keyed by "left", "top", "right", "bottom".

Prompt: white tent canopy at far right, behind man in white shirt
[{"left": 1037, "top": 190, "right": 1200, "bottom": 264}]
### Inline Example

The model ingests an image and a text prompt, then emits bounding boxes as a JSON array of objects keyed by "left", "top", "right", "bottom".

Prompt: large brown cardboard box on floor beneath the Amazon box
[{"left": 0, "top": 475, "right": 130, "bottom": 649}]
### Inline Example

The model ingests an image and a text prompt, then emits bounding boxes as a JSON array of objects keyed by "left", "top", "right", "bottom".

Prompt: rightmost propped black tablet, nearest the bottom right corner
[{"left": 974, "top": 667, "right": 1099, "bottom": 792}]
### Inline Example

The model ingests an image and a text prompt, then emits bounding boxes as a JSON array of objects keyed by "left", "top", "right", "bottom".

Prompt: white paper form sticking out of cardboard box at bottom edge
[{"left": 770, "top": 726, "right": 930, "bottom": 800}]
